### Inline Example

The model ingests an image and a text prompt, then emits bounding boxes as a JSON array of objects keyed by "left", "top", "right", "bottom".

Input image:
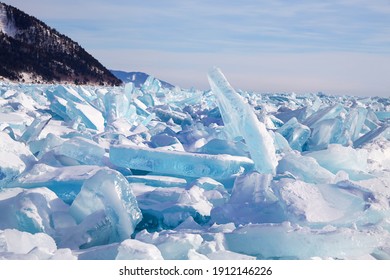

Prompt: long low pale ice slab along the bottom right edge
[{"left": 225, "top": 223, "right": 389, "bottom": 260}]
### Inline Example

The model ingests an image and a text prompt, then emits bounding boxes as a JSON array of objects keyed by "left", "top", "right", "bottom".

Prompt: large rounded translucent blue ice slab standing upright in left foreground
[{"left": 69, "top": 167, "right": 142, "bottom": 245}]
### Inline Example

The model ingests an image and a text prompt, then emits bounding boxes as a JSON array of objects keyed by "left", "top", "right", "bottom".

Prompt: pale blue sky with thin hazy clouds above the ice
[{"left": 1, "top": 0, "right": 390, "bottom": 97}]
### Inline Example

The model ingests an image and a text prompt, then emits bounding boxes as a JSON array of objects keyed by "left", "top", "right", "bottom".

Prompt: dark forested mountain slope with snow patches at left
[{"left": 0, "top": 2, "right": 121, "bottom": 85}]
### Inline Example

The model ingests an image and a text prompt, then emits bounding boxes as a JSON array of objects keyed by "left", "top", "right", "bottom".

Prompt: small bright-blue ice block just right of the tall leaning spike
[{"left": 277, "top": 117, "right": 311, "bottom": 151}]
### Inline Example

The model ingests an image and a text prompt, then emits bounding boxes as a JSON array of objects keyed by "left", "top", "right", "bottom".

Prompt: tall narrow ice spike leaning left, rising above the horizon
[{"left": 208, "top": 68, "right": 277, "bottom": 174}]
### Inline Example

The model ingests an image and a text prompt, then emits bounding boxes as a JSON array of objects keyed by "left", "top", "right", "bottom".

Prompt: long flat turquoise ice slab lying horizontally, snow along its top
[{"left": 110, "top": 145, "right": 253, "bottom": 179}]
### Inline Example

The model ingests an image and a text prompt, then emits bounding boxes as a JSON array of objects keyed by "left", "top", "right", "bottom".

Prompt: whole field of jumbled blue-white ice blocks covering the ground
[{"left": 0, "top": 68, "right": 390, "bottom": 259}]
